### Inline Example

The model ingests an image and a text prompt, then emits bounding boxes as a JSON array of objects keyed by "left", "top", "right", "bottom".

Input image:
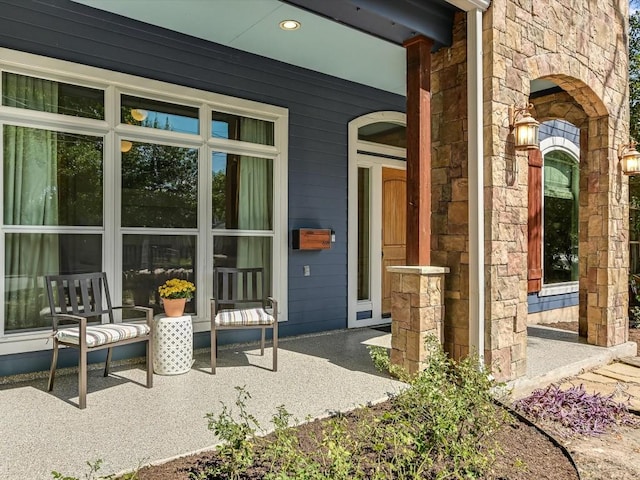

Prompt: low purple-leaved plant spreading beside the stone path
[{"left": 513, "top": 384, "right": 637, "bottom": 435}]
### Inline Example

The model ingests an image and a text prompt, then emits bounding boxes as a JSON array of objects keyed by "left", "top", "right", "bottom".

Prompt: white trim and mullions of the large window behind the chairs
[{"left": 0, "top": 48, "right": 289, "bottom": 355}]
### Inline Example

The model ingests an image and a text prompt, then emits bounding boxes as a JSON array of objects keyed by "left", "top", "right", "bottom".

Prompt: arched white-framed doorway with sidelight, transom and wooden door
[{"left": 347, "top": 112, "right": 406, "bottom": 328}]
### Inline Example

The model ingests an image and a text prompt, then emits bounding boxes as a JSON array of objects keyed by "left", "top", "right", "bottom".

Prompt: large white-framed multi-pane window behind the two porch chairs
[{"left": 0, "top": 51, "right": 288, "bottom": 340}]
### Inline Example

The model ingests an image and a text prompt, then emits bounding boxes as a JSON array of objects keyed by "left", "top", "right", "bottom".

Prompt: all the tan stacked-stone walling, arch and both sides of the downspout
[{"left": 432, "top": 0, "right": 628, "bottom": 379}]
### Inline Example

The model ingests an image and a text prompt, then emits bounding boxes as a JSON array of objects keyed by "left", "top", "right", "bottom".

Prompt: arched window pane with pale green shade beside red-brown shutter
[{"left": 543, "top": 150, "right": 579, "bottom": 284}]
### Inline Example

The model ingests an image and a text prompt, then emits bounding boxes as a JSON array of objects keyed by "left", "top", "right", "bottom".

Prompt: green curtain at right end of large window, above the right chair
[{"left": 237, "top": 118, "right": 273, "bottom": 292}]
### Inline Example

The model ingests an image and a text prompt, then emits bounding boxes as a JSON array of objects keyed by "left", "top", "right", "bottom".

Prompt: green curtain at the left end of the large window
[{"left": 3, "top": 75, "right": 59, "bottom": 331}]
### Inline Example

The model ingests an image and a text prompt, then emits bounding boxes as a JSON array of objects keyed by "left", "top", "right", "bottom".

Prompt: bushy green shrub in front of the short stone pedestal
[{"left": 384, "top": 337, "right": 507, "bottom": 478}]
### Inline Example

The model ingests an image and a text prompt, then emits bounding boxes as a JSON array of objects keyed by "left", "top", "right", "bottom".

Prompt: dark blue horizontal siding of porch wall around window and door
[{"left": 0, "top": 0, "right": 405, "bottom": 375}]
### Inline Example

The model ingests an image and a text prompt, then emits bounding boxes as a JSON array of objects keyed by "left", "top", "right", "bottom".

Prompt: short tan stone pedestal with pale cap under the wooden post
[{"left": 387, "top": 266, "right": 449, "bottom": 374}]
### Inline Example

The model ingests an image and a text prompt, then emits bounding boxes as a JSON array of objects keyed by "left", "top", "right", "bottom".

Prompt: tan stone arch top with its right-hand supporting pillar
[{"left": 528, "top": 63, "right": 628, "bottom": 346}]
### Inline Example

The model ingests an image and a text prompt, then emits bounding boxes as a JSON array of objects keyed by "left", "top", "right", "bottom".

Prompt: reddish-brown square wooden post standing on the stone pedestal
[{"left": 404, "top": 35, "right": 433, "bottom": 266}]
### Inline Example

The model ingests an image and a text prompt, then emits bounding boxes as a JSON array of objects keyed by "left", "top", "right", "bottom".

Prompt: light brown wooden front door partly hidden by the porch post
[{"left": 382, "top": 167, "right": 407, "bottom": 317}]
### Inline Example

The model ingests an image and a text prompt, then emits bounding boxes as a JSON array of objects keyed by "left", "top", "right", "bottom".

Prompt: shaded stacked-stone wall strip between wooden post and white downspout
[{"left": 431, "top": 14, "right": 469, "bottom": 358}]
